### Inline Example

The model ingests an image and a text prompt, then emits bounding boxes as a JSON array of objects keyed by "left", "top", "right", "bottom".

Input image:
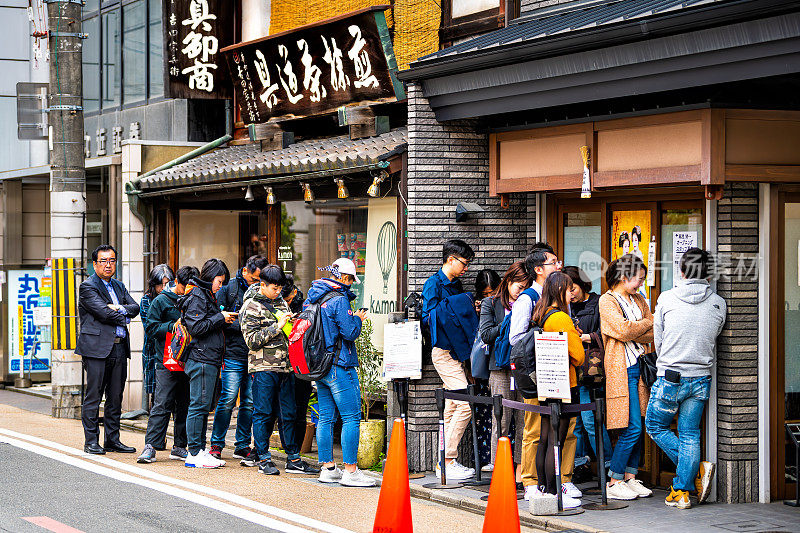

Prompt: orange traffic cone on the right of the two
[{"left": 483, "top": 437, "right": 520, "bottom": 533}]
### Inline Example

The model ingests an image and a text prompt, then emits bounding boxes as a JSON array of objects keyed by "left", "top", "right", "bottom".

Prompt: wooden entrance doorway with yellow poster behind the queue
[{"left": 547, "top": 190, "right": 704, "bottom": 487}]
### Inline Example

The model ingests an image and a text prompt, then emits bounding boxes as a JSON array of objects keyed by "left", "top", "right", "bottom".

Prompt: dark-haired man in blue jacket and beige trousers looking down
[{"left": 422, "top": 239, "right": 475, "bottom": 481}]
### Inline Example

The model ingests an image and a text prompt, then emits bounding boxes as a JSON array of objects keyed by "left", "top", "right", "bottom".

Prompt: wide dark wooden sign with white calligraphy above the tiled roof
[{"left": 222, "top": 6, "right": 405, "bottom": 124}]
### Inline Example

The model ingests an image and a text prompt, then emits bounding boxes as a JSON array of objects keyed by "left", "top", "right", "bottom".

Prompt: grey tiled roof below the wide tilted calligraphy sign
[{"left": 139, "top": 128, "right": 408, "bottom": 189}]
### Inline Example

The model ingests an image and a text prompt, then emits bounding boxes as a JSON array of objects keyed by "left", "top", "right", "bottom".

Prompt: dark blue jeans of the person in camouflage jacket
[{"left": 250, "top": 371, "right": 300, "bottom": 461}]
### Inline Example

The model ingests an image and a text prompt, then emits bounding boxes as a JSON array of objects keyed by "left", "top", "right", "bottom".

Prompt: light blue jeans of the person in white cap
[{"left": 317, "top": 365, "right": 361, "bottom": 465}]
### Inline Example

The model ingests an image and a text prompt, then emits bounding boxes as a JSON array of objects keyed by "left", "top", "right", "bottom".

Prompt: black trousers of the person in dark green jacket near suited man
[{"left": 144, "top": 361, "right": 189, "bottom": 450}]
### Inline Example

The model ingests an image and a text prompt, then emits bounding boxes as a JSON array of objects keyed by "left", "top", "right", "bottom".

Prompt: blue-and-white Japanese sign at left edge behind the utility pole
[{"left": 8, "top": 270, "right": 50, "bottom": 372}]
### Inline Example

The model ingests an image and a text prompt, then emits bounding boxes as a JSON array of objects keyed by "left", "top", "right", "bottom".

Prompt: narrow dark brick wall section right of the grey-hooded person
[{"left": 717, "top": 183, "right": 758, "bottom": 503}]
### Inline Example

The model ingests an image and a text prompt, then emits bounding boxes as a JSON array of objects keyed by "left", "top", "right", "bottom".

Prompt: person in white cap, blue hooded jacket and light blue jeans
[{"left": 305, "top": 258, "right": 375, "bottom": 487}]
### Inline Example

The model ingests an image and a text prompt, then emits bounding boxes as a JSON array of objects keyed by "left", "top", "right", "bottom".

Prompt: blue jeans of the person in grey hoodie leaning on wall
[{"left": 645, "top": 376, "right": 711, "bottom": 490}]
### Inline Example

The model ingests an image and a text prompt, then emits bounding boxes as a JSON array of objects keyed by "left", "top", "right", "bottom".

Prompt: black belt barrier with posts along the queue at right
[{"left": 423, "top": 385, "right": 628, "bottom": 512}]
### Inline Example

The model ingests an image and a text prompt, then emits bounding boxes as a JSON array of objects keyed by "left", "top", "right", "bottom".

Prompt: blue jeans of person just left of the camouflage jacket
[{"left": 211, "top": 359, "right": 253, "bottom": 450}]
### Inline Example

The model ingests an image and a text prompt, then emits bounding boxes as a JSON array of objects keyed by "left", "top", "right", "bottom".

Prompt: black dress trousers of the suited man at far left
[{"left": 81, "top": 343, "right": 128, "bottom": 445}]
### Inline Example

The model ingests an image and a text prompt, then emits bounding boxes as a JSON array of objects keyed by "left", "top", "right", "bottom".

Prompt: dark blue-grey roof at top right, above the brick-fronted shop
[{"left": 411, "top": 0, "right": 722, "bottom": 62}]
